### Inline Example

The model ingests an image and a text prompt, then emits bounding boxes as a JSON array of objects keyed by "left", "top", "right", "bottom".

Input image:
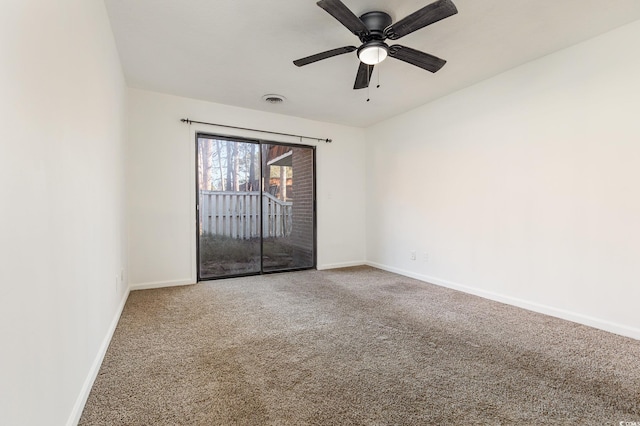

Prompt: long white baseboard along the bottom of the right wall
[{"left": 366, "top": 262, "right": 640, "bottom": 340}]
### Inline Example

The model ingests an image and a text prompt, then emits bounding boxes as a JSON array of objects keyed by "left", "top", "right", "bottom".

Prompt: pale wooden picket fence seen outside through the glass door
[{"left": 200, "top": 191, "right": 293, "bottom": 239}]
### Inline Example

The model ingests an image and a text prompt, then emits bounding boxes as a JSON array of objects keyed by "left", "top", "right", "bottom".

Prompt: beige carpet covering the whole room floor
[{"left": 80, "top": 267, "right": 640, "bottom": 425}]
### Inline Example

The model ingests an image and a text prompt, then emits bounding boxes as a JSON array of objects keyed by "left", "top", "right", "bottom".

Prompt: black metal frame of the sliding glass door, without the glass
[{"left": 195, "top": 131, "right": 318, "bottom": 282}]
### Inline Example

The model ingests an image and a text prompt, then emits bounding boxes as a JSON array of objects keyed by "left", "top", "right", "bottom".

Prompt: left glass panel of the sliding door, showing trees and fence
[{"left": 197, "top": 135, "right": 261, "bottom": 279}]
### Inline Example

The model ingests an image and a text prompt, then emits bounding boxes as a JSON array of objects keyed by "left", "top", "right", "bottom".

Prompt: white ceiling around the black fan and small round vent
[{"left": 105, "top": 0, "right": 640, "bottom": 127}]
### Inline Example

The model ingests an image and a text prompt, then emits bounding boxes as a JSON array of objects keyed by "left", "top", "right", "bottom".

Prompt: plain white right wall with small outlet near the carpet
[{"left": 366, "top": 22, "right": 640, "bottom": 338}]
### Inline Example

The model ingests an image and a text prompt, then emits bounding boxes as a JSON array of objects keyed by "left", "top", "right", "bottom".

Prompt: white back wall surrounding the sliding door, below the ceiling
[{"left": 127, "top": 89, "right": 365, "bottom": 288}]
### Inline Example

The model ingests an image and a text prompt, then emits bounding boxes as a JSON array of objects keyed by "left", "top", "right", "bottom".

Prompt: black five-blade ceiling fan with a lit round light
[{"left": 293, "top": 0, "right": 458, "bottom": 89}]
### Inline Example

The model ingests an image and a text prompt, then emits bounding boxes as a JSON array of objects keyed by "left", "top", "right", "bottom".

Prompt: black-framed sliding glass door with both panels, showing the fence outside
[{"left": 197, "top": 134, "right": 315, "bottom": 280}]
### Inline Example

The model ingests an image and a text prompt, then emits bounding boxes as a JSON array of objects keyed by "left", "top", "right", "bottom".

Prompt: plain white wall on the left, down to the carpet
[{"left": 0, "top": 0, "right": 127, "bottom": 425}]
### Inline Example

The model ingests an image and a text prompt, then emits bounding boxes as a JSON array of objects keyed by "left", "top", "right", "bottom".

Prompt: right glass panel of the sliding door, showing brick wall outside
[{"left": 262, "top": 143, "right": 316, "bottom": 272}]
